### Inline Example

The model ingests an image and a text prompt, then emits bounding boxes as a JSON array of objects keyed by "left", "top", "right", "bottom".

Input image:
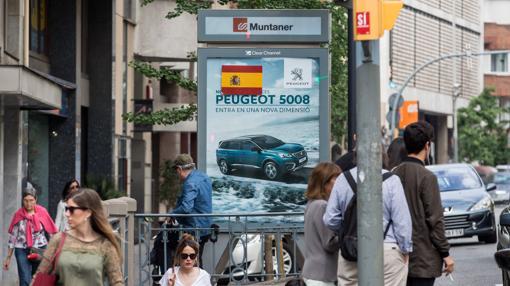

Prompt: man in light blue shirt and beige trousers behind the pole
[{"left": 323, "top": 152, "right": 413, "bottom": 286}]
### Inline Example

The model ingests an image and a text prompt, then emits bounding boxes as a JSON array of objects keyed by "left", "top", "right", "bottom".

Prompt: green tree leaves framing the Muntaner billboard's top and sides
[{"left": 123, "top": 0, "right": 348, "bottom": 142}]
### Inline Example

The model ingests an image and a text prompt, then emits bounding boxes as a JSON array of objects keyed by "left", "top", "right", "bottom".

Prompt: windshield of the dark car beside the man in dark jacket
[{"left": 432, "top": 167, "right": 482, "bottom": 192}]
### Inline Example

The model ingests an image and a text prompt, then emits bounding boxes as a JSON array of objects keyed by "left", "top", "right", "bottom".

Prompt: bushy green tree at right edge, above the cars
[{"left": 458, "top": 89, "right": 510, "bottom": 166}]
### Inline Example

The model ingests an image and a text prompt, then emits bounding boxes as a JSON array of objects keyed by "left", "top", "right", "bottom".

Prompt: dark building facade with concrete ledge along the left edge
[{"left": 0, "top": 0, "right": 150, "bottom": 285}]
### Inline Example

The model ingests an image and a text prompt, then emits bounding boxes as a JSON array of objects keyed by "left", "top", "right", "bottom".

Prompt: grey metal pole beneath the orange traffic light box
[{"left": 356, "top": 40, "right": 384, "bottom": 286}]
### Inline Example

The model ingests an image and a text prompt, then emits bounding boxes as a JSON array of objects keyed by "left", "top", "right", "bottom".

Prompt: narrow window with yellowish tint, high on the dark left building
[{"left": 30, "top": 0, "right": 48, "bottom": 55}]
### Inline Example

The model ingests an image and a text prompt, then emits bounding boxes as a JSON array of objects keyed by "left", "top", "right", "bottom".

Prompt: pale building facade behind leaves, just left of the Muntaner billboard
[{"left": 135, "top": 1, "right": 203, "bottom": 212}]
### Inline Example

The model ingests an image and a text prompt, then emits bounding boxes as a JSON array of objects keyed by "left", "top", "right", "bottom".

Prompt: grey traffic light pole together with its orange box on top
[{"left": 352, "top": 0, "right": 404, "bottom": 286}]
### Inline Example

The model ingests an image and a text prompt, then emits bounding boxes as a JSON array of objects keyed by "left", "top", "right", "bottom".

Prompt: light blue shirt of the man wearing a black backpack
[{"left": 323, "top": 168, "right": 413, "bottom": 253}]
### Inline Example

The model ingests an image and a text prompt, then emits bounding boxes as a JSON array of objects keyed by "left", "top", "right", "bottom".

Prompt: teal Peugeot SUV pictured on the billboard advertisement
[{"left": 216, "top": 135, "right": 308, "bottom": 180}]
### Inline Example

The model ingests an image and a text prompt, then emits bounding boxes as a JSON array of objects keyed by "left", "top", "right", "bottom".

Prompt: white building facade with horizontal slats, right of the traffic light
[{"left": 381, "top": 0, "right": 483, "bottom": 163}]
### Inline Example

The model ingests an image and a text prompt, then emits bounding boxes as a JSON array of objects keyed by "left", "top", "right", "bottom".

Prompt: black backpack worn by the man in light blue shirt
[{"left": 340, "top": 171, "right": 393, "bottom": 262}]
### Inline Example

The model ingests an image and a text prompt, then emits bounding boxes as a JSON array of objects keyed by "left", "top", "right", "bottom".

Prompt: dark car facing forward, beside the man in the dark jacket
[{"left": 427, "top": 164, "right": 497, "bottom": 243}]
